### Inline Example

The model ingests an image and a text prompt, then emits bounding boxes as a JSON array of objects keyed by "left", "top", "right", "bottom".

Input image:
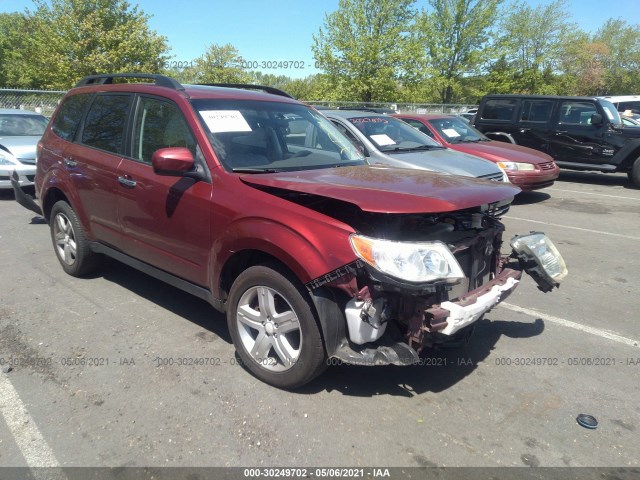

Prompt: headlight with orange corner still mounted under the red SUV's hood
[{"left": 351, "top": 234, "right": 464, "bottom": 283}]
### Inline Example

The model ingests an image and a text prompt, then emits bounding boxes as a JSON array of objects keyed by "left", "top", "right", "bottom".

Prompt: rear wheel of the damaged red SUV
[{"left": 49, "top": 200, "right": 102, "bottom": 277}]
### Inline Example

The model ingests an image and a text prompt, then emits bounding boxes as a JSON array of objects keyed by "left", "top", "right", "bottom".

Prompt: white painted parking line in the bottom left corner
[{"left": 0, "top": 373, "right": 67, "bottom": 480}]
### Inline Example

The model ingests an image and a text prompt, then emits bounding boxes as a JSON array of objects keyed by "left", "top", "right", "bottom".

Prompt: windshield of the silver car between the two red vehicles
[{"left": 349, "top": 116, "right": 443, "bottom": 152}]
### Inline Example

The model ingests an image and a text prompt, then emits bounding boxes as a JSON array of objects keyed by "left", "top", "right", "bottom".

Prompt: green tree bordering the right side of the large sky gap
[{"left": 311, "top": 0, "right": 416, "bottom": 102}]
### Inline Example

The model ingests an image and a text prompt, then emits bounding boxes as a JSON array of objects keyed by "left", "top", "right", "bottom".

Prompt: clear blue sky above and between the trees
[{"left": 0, "top": 0, "right": 640, "bottom": 78}]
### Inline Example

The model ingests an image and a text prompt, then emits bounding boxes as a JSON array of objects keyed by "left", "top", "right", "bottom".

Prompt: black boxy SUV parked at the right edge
[{"left": 474, "top": 95, "right": 640, "bottom": 187}]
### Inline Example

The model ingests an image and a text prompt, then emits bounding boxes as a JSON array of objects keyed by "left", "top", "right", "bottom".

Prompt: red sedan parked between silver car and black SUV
[{"left": 393, "top": 113, "right": 560, "bottom": 190}]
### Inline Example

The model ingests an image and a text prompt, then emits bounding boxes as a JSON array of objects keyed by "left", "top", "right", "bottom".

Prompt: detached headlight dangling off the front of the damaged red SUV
[{"left": 511, "top": 232, "right": 568, "bottom": 292}]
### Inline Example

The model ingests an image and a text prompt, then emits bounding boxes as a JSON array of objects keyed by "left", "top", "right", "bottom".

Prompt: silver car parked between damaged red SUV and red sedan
[{"left": 322, "top": 110, "right": 508, "bottom": 181}]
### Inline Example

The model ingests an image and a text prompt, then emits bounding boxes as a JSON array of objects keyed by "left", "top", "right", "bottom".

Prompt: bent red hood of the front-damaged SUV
[{"left": 240, "top": 165, "right": 520, "bottom": 213}]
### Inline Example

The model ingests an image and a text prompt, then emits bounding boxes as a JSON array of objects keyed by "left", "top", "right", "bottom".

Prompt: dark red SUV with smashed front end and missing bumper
[{"left": 16, "top": 74, "right": 566, "bottom": 388}]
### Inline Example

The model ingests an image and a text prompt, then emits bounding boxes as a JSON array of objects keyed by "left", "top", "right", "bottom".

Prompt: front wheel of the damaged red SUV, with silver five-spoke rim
[{"left": 227, "top": 265, "right": 327, "bottom": 389}]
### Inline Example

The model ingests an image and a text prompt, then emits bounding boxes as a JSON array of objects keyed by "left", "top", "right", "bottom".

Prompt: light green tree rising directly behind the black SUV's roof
[{"left": 498, "top": 0, "right": 577, "bottom": 93}]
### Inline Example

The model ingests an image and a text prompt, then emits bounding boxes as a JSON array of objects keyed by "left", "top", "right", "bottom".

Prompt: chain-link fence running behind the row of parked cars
[{"left": 0, "top": 88, "right": 476, "bottom": 117}]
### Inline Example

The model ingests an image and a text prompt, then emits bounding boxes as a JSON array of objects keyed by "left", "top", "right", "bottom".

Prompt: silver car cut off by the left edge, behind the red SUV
[{"left": 0, "top": 109, "right": 49, "bottom": 189}]
